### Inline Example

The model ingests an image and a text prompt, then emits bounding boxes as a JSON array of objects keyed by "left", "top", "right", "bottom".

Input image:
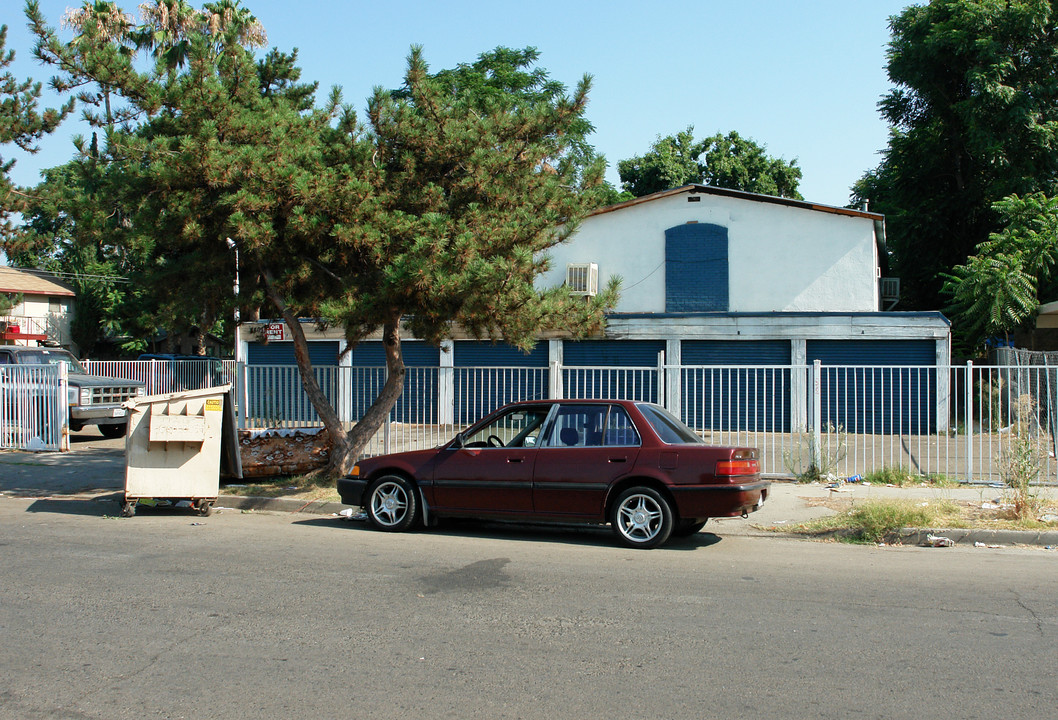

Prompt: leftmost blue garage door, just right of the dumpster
[{"left": 247, "top": 341, "right": 340, "bottom": 426}]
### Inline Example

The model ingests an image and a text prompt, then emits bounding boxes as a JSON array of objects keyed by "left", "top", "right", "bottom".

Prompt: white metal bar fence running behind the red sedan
[{"left": 8, "top": 359, "right": 1058, "bottom": 482}]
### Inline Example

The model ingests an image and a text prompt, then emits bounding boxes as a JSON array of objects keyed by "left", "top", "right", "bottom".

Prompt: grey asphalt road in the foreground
[{"left": 0, "top": 497, "right": 1058, "bottom": 720}]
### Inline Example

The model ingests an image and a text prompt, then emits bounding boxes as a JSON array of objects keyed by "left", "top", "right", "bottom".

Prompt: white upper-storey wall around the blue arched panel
[{"left": 539, "top": 192, "right": 880, "bottom": 313}]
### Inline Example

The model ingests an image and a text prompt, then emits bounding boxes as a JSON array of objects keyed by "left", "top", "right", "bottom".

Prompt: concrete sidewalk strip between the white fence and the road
[{"left": 6, "top": 438, "right": 1058, "bottom": 547}]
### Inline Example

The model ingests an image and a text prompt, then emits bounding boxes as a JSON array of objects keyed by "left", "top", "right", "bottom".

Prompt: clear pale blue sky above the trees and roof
[{"left": 0, "top": 0, "right": 912, "bottom": 205}]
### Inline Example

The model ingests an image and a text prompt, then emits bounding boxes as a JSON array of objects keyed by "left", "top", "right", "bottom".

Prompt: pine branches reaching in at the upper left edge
[{"left": 0, "top": 25, "right": 73, "bottom": 237}]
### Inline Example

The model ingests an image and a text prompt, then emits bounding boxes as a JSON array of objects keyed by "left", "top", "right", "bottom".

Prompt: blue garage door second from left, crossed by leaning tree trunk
[{"left": 349, "top": 340, "right": 440, "bottom": 424}]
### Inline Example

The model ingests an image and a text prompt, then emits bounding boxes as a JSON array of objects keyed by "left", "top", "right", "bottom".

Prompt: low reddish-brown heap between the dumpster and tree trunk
[{"left": 239, "top": 428, "right": 331, "bottom": 478}]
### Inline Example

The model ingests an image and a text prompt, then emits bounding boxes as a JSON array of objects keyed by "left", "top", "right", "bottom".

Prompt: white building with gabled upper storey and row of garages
[{"left": 242, "top": 185, "right": 951, "bottom": 429}]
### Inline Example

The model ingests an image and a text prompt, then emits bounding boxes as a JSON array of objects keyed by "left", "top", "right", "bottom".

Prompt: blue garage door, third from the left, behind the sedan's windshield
[{"left": 452, "top": 340, "right": 548, "bottom": 425}]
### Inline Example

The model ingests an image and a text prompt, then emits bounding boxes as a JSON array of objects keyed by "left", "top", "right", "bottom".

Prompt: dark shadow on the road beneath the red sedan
[{"left": 294, "top": 517, "right": 722, "bottom": 551}]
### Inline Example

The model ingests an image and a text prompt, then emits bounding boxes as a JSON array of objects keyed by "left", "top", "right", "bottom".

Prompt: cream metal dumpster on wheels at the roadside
[{"left": 122, "top": 385, "right": 235, "bottom": 517}]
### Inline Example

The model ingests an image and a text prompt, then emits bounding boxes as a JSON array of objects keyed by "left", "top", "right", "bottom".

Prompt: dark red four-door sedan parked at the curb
[{"left": 338, "top": 400, "right": 770, "bottom": 548}]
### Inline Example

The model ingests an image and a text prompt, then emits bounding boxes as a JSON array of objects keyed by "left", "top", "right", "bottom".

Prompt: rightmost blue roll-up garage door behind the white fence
[{"left": 807, "top": 340, "right": 937, "bottom": 435}]
